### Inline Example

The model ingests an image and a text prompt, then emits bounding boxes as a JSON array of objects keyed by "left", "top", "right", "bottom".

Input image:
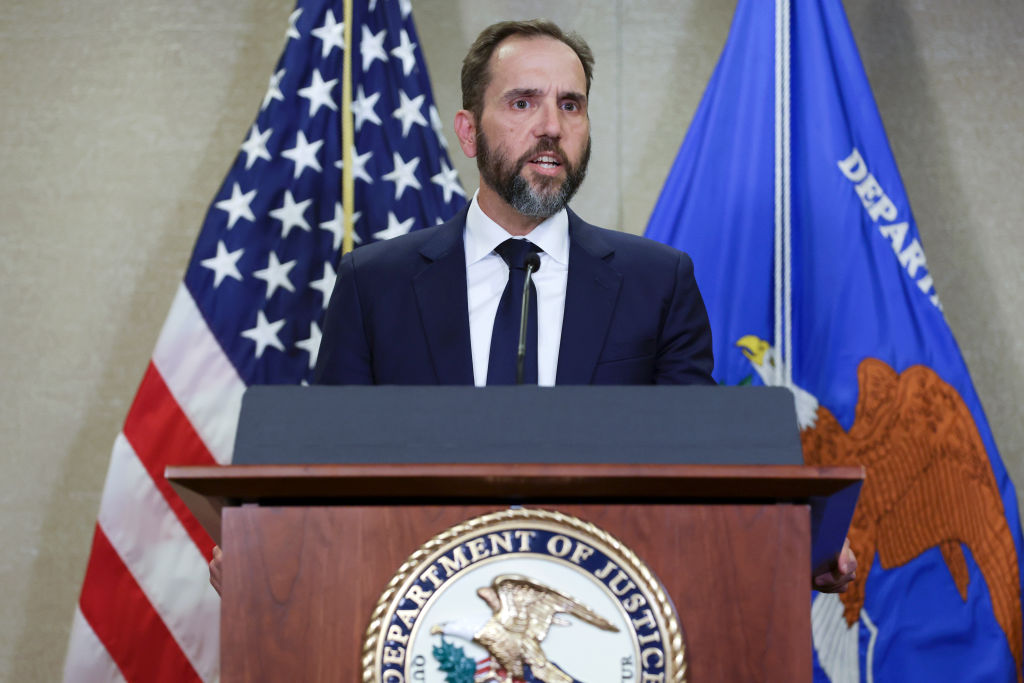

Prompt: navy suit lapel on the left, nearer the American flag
[{"left": 413, "top": 210, "right": 473, "bottom": 384}]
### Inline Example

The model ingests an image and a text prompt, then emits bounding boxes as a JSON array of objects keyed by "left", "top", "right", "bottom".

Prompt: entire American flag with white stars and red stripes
[{"left": 65, "top": 0, "right": 466, "bottom": 683}]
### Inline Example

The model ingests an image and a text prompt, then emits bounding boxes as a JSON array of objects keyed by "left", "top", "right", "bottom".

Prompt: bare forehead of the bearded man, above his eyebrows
[{"left": 486, "top": 36, "right": 587, "bottom": 96}]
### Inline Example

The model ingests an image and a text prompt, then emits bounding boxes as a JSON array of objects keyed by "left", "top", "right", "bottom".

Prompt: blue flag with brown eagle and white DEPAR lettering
[{"left": 647, "top": 0, "right": 1024, "bottom": 681}]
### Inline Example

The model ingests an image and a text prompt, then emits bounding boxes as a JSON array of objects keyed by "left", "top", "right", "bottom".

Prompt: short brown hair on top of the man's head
[{"left": 462, "top": 19, "right": 594, "bottom": 120}]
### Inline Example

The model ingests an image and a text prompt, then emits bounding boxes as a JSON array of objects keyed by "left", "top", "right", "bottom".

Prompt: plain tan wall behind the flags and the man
[{"left": 0, "top": 0, "right": 1024, "bottom": 681}]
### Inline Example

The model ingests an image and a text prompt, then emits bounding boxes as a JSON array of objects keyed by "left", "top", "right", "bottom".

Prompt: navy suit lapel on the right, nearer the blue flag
[{"left": 555, "top": 211, "right": 623, "bottom": 384}]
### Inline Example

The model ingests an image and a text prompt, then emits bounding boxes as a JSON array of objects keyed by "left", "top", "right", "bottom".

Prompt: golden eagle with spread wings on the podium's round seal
[{"left": 430, "top": 574, "right": 618, "bottom": 683}]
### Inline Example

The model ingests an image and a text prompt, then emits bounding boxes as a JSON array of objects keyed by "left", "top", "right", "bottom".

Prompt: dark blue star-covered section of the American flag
[{"left": 185, "top": 0, "right": 466, "bottom": 384}]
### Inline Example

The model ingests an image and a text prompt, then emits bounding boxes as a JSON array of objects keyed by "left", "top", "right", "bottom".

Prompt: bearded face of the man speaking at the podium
[{"left": 475, "top": 38, "right": 590, "bottom": 219}]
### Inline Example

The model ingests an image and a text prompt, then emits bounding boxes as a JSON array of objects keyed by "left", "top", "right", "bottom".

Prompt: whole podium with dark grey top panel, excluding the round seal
[{"left": 167, "top": 387, "right": 863, "bottom": 683}]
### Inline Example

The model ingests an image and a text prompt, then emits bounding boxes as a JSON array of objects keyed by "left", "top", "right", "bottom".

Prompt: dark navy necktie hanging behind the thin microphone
[{"left": 487, "top": 240, "right": 542, "bottom": 385}]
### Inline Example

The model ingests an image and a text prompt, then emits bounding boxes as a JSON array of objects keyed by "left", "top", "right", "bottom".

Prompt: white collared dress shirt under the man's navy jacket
[{"left": 463, "top": 195, "right": 569, "bottom": 386}]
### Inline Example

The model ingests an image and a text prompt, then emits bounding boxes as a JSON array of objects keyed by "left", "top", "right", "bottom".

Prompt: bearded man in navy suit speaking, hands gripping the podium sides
[{"left": 210, "top": 15, "right": 856, "bottom": 593}]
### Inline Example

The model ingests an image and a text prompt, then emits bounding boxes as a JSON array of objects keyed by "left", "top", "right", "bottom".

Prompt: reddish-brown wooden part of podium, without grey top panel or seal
[{"left": 167, "top": 463, "right": 863, "bottom": 683}]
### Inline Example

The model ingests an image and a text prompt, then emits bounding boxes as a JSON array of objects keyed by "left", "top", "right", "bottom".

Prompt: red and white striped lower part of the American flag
[{"left": 65, "top": 285, "right": 245, "bottom": 683}]
